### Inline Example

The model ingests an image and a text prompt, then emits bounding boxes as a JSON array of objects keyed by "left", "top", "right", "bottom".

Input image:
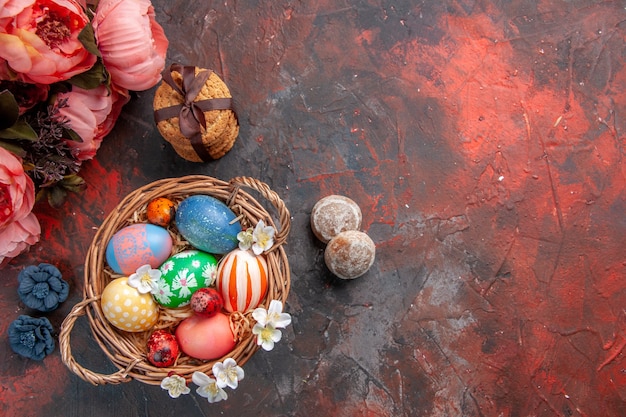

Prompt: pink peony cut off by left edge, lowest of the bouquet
[{"left": 0, "top": 148, "right": 41, "bottom": 265}]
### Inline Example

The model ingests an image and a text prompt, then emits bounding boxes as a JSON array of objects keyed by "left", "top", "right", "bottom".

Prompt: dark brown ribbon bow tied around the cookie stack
[{"left": 154, "top": 63, "right": 234, "bottom": 162}]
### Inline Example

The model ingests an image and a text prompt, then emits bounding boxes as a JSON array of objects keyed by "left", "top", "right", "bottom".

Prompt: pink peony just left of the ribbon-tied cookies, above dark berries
[{"left": 57, "top": 85, "right": 130, "bottom": 161}]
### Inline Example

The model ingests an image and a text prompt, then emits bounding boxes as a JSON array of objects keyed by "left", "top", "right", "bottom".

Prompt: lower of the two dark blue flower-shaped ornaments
[{"left": 9, "top": 315, "right": 54, "bottom": 361}]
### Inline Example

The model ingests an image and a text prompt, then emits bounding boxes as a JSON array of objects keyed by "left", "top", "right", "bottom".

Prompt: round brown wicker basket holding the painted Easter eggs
[{"left": 59, "top": 175, "right": 291, "bottom": 385}]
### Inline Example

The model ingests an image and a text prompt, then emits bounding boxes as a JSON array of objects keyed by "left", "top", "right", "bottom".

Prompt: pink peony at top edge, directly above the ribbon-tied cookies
[{"left": 93, "top": 0, "right": 168, "bottom": 91}]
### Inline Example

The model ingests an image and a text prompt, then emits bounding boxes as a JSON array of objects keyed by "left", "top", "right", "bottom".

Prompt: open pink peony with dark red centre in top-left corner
[{"left": 0, "top": 0, "right": 96, "bottom": 84}]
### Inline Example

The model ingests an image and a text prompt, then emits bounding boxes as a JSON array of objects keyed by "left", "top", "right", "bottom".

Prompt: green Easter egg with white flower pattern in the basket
[{"left": 153, "top": 250, "right": 217, "bottom": 308}]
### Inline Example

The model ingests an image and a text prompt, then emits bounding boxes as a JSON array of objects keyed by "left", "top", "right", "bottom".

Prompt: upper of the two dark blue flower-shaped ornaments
[{"left": 17, "top": 263, "right": 70, "bottom": 313}]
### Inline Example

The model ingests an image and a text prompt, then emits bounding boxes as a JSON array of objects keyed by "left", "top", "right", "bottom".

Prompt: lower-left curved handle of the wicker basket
[{"left": 59, "top": 298, "right": 139, "bottom": 385}]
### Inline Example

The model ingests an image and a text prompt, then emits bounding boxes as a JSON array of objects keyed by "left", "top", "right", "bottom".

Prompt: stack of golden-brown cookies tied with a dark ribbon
[{"left": 153, "top": 67, "right": 239, "bottom": 162}]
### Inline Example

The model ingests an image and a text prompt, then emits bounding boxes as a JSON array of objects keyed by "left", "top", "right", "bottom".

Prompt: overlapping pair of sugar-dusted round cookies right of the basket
[{"left": 311, "top": 195, "right": 376, "bottom": 279}]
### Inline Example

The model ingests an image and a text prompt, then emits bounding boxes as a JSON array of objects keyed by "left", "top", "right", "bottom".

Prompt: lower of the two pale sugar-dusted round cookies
[{"left": 324, "top": 230, "right": 376, "bottom": 279}]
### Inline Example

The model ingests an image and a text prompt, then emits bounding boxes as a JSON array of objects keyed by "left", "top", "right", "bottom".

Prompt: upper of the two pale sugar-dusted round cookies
[{"left": 311, "top": 194, "right": 363, "bottom": 243}]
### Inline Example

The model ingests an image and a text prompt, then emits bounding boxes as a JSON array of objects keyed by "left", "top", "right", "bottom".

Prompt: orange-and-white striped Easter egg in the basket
[{"left": 215, "top": 249, "right": 267, "bottom": 313}]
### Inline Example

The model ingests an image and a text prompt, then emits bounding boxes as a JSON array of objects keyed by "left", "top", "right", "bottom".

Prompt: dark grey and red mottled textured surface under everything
[{"left": 0, "top": 0, "right": 626, "bottom": 417}]
